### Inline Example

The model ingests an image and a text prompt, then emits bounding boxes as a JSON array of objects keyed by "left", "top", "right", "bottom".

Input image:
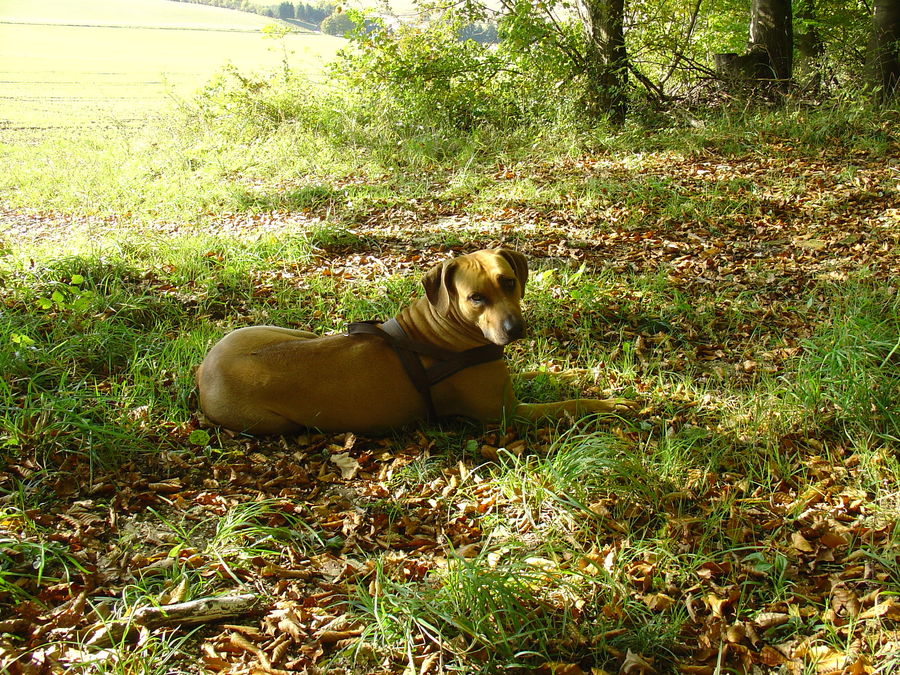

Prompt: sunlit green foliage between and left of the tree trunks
[{"left": 322, "top": 0, "right": 870, "bottom": 125}]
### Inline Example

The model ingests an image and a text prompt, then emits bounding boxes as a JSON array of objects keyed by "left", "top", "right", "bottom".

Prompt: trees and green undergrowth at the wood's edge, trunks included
[{"left": 345, "top": 0, "right": 900, "bottom": 123}]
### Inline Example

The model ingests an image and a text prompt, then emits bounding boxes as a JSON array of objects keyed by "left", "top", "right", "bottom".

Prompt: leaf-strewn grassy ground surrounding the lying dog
[{"left": 0, "top": 19, "right": 900, "bottom": 673}]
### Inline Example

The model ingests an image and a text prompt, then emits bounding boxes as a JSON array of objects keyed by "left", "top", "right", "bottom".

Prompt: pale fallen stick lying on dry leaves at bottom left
[{"left": 87, "top": 594, "right": 257, "bottom": 647}]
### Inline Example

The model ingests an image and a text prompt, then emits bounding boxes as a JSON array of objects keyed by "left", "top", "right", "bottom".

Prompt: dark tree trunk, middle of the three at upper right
[{"left": 748, "top": 0, "right": 794, "bottom": 92}]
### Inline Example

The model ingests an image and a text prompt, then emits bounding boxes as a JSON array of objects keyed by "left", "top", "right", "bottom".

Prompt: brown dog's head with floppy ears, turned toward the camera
[{"left": 422, "top": 248, "right": 528, "bottom": 345}]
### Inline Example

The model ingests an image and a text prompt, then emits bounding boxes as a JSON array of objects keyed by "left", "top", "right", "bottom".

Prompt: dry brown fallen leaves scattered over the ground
[{"left": 0, "top": 145, "right": 900, "bottom": 675}]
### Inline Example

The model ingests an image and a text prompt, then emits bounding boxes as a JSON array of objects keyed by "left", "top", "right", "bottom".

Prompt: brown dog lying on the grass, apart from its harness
[{"left": 197, "top": 249, "right": 630, "bottom": 434}]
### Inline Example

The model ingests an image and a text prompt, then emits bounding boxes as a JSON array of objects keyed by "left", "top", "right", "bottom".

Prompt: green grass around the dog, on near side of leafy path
[{"left": 0, "top": 217, "right": 900, "bottom": 672}]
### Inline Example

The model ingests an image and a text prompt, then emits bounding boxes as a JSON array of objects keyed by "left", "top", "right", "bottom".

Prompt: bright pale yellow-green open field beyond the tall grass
[{"left": 0, "top": 0, "right": 344, "bottom": 128}]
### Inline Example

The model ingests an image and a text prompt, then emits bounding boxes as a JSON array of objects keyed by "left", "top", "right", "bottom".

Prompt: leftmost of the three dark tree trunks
[{"left": 583, "top": 0, "right": 628, "bottom": 125}]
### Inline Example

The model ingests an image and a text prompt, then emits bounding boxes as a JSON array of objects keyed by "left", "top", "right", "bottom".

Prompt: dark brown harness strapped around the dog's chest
[{"left": 347, "top": 319, "right": 503, "bottom": 422}]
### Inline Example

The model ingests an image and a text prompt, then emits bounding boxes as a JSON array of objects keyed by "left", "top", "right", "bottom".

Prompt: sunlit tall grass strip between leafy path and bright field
[{"left": 0, "top": 64, "right": 896, "bottom": 221}]
